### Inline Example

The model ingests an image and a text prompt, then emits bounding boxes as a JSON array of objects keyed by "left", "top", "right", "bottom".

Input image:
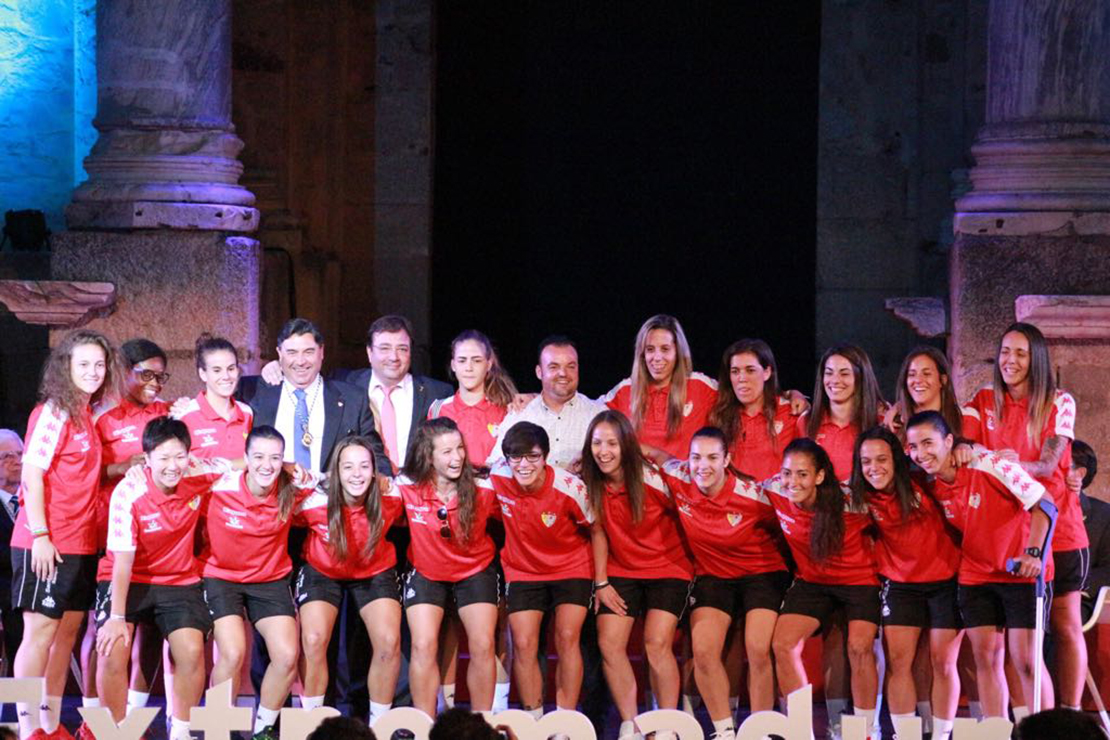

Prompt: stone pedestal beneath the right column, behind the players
[{"left": 949, "top": 226, "right": 1110, "bottom": 490}]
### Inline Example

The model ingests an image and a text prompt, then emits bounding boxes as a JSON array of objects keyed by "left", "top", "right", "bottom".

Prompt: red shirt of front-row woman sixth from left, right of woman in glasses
[{"left": 602, "top": 465, "right": 694, "bottom": 580}]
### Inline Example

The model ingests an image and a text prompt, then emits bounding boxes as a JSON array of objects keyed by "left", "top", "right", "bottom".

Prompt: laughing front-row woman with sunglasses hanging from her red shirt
[{"left": 394, "top": 417, "right": 497, "bottom": 717}]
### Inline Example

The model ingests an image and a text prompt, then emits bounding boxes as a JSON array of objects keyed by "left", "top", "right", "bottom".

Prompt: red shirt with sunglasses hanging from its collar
[{"left": 392, "top": 476, "right": 497, "bottom": 584}]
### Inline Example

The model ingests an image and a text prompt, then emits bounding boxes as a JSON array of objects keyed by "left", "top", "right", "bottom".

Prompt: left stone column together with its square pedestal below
[{"left": 51, "top": 0, "right": 262, "bottom": 397}]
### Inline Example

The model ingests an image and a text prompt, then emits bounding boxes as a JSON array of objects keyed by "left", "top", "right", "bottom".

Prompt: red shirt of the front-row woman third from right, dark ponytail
[{"left": 764, "top": 476, "right": 879, "bottom": 586}]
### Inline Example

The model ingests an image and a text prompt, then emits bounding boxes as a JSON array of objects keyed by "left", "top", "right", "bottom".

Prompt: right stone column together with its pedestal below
[{"left": 949, "top": 0, "right": 1110, "bottom": 497}]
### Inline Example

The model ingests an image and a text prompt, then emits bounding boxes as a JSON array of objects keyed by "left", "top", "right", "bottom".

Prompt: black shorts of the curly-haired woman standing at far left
[{"left": 11, "top": 547, "right": 98, "bottom": 619}]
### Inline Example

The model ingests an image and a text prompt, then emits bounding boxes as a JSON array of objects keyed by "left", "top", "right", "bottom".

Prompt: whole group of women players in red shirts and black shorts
[{"left": 4, "top": 315, "right": 1087, "bottom": 740}]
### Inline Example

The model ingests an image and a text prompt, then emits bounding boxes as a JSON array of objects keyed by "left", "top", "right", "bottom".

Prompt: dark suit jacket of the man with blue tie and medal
[{"left": 239, "top": 375, "right": 393, "bottom": 475}]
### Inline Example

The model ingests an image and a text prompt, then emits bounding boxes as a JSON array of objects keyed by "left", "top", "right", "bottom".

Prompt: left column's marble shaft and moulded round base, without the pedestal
[{"left": 65, "top": 0, "right": 259, "bottom": 232}]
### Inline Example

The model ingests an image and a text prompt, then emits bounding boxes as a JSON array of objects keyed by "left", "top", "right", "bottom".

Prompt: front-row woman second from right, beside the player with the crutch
[{"left": 849, "top": 426, "right": 963, "bottom": 740}]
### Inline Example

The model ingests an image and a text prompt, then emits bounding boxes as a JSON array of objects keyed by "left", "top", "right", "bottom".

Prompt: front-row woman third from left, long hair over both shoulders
[{"left": 293, "top": 437, "right": 403, "bottom": 723}]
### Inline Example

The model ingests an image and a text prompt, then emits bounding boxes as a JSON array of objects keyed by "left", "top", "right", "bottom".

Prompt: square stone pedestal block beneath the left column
[{"left": 50, "top": 230, "right": 262, "bottom": 398}]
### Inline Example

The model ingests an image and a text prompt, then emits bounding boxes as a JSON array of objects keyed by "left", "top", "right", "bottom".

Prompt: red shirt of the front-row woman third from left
[{"left": 293, "top": 488, "right": 404, "bottom": 580}]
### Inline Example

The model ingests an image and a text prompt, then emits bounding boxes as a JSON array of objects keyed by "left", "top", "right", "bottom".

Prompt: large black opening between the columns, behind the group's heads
[{"left": 432, "top": 1, "right": 820, "bottom": 395}]
